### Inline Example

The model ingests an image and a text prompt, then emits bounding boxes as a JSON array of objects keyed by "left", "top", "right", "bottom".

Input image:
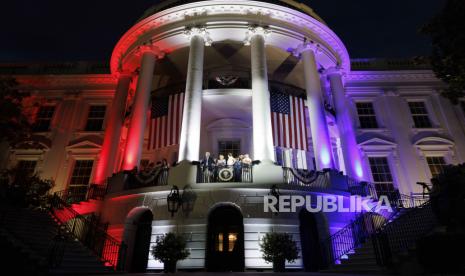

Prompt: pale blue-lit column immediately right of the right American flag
[{"left": 295, "top": 42, "right": 334, "bottom": 170}]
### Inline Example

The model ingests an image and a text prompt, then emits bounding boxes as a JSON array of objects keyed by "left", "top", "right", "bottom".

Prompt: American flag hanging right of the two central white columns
[{"left": 270, "top": 91, "right": 308, "bottom": 151}]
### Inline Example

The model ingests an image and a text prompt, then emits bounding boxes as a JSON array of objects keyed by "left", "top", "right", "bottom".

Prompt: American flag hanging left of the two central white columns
[{"left": 148, "top": 93, "right": 184, "bottom": 150}]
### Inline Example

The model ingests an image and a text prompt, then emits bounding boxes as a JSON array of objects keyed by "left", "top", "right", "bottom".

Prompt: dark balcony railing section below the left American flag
[{"left": 124, "top": 168, "right": 169, "bottom": 190}]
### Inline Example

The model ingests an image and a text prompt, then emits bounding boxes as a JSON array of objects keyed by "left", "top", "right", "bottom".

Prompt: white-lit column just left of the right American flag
[{"left": 246, "top": 27, "right": 275, "bottom": 163}]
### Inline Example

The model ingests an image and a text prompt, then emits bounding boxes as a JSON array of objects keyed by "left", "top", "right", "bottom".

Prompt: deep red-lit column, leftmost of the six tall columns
[{"left": 93, "top": 72, "right": 132, "bottom": 184}]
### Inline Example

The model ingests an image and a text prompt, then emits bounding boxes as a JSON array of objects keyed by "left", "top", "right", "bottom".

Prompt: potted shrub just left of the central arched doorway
[{"left": 151, "top": 233, "right": 190, "bottom": 273}]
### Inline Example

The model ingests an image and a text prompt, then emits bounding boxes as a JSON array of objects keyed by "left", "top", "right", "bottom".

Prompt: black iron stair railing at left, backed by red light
[{"left": 50, "top": 192, "right": 126, "bottom": 270}]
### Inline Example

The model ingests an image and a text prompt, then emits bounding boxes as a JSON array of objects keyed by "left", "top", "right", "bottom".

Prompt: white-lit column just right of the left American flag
[{"left": 178, "top": 28, "right": 210, "bottom": 162}]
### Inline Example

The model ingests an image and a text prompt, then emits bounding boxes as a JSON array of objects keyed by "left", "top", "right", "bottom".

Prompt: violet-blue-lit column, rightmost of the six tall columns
[{"left": 326, "top": 67, "right": 367, "bottom": 180}]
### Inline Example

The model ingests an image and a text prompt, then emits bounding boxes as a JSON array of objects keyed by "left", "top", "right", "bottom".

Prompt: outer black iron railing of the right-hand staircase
[{"left": 372, "top": 201, "right": 436, "bottom": 266}]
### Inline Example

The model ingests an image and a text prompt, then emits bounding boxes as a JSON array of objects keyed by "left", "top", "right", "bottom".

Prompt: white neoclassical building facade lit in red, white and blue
[{"left": 0, "top": 0, "right": 465, "bottom": 271}]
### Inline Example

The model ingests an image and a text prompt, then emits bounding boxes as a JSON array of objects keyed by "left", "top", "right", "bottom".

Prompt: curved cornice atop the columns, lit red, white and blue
[{"left": 110, "top": 0, "right": 350, "bottom": 72}]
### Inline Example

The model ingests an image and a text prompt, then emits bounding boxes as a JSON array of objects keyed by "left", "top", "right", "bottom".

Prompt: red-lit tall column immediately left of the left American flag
[{"left": 123, "top": 46, "right": 163, "bottom": 170}]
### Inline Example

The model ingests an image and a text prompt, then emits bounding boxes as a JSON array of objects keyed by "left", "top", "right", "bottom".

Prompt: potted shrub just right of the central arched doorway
[{"left": 260, "top": 232, "right": 299, "bottom": 272}]
